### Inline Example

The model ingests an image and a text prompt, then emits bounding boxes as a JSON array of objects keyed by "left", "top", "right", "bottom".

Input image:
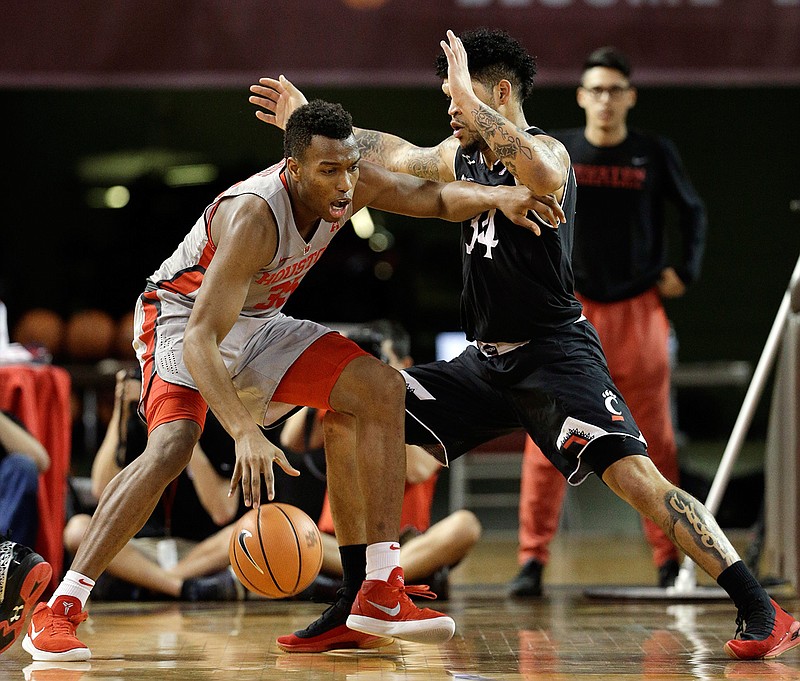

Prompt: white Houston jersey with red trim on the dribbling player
[{"left": 148, "top": 160, "right": 352, "bottom": 317}]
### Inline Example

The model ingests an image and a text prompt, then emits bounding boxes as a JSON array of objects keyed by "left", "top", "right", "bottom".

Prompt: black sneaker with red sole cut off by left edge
[{"left": 0, "top": 534, "right": 53, "bottom": 653}]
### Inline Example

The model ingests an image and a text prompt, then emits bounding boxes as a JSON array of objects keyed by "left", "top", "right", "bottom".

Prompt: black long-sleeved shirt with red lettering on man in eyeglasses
[{"left": 553, "top": 128, "right": 706, "bottom": 302}]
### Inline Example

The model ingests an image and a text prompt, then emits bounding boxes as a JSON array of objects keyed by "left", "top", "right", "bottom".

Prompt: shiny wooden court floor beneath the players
[{"left": 0, "top": 538, "right": 800, "bottom": 681}]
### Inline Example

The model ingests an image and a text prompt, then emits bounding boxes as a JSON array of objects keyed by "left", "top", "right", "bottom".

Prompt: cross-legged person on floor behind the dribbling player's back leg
[{"left": 64, "top": 371, "right": 245, "bottom": 601}]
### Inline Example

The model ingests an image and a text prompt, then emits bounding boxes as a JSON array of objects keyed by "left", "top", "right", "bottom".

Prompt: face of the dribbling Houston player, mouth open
[{"left": 288, "top": 135, "right": 361, "bottom": 222}]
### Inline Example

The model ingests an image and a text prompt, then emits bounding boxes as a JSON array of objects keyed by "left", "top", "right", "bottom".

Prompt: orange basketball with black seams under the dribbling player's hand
[{"left": 229, "top": 502, "right": 322, "bottom": 598}]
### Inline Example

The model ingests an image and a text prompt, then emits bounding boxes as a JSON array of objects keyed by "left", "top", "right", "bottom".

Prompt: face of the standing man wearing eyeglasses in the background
[{"left": 578, "top": 66, "right": 636, "bottom": 130}]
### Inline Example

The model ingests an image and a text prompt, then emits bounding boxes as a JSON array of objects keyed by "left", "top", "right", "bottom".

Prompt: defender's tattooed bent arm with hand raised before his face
[{"left": 441, "top": 31, "right": 569, "bottom": 198}]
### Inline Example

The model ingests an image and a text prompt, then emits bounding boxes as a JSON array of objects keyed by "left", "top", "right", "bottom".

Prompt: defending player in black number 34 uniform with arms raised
[{"left": 250, "top": 29, "right": 800, "bottom": 659}]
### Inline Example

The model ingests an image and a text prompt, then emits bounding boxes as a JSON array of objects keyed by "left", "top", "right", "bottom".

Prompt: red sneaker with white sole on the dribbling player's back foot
[{"left": 22, "top": 596, "right": 92, "bottom": 662}]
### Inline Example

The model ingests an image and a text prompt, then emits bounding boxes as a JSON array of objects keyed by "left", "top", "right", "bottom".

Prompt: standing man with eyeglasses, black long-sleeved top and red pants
[{"left": 510, "top": 47, "right": 706, "bottom": 597}]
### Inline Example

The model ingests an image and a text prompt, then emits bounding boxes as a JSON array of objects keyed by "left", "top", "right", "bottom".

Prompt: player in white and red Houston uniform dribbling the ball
[{"left": 23, "top": 101, "right": 552, "bottom": 660}]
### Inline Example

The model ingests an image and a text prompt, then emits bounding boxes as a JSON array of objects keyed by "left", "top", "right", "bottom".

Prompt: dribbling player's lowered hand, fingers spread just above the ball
[{"left": 228, "top": 431, "right": 300, "bottom": 508}]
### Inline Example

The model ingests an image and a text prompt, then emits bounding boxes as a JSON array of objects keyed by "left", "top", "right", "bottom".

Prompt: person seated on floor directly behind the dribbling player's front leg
[{"left": 281, "top": 320, "right": 481, "bottom": 600}]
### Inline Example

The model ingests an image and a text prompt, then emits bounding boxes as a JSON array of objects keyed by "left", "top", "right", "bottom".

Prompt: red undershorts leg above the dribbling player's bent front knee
[{"left": 272, "top": 331, "right": 372, "bottom": 409}]
